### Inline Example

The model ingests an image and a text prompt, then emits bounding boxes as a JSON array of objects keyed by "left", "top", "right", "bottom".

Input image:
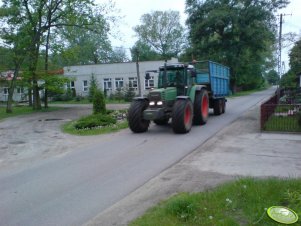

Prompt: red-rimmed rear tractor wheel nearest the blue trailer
[{"left": 193, "top": 89, "right": 209, "bottom": 125}]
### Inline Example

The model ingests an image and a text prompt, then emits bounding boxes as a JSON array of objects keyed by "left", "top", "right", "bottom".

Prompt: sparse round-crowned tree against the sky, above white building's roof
[{"left": 134, "top": 11, "right": 185, "bottom": 59}]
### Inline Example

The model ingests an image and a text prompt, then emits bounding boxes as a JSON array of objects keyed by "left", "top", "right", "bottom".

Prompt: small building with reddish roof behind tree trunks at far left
[{"left": 0, "top": 71, "right": 28, "bottom": 102}]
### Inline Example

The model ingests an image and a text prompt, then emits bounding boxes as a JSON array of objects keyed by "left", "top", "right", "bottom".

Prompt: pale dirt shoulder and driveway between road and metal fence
[{"left": 86, "top": 103, "right": 301, "bottom": 226}]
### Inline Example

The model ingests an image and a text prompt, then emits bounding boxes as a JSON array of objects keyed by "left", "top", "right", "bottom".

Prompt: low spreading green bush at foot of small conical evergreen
[{"left": 74, "top": 114, "right": 116, "bottom": 129}]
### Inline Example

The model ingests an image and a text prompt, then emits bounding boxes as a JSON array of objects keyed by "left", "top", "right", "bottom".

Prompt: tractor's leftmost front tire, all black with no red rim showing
[{"left": 128, "top": 100, "right": 150, "bottom": 133}]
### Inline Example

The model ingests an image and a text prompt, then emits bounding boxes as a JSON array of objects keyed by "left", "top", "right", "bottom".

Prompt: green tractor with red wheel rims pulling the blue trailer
[{"left": 128, "top": 64, "right": 209, "bottom": 133}]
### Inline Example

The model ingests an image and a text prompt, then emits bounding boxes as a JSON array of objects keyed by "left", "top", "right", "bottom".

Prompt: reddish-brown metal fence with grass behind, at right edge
[{"left": 260, "top": 90, "right": 301, "bottom": 132}]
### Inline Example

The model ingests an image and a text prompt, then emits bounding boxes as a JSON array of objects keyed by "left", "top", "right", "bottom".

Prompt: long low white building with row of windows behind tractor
[{"left": 64, "top": 58, "right": 178, "bottom": 96}]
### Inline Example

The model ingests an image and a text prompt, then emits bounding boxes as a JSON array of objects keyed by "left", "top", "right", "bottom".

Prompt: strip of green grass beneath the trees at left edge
[{"left": 0, "top": 106, "right": 60, "bottom": 120}]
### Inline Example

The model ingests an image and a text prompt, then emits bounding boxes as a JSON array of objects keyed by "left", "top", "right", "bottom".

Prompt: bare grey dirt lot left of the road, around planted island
[{"left": 0, "top": 104, "right": 128, "bottom": 170}]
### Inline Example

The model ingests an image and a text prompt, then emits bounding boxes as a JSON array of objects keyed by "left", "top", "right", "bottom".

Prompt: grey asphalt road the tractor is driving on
[{"left": 0, "top": 87, "right": 274, "bottom": 226}]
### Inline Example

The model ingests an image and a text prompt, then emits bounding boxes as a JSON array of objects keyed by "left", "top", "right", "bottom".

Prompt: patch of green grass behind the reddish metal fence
[{"left": 264, "top": 115, "right": 301, "bottom": 132}]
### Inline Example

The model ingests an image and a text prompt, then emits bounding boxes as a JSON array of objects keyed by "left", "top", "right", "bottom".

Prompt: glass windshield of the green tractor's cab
[{"left": 158, "top": 68, "right": 185, "bottom": 88}]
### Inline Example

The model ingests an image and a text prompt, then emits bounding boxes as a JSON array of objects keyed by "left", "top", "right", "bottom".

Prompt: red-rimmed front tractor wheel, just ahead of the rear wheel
[{"left": 172, "top": 99, "right": 193, "bottom": 133}]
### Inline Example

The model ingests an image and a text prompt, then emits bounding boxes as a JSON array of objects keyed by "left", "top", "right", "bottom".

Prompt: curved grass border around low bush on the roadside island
[{"left": 62, "top": 120, "right": 128, "bottom": 136}]
